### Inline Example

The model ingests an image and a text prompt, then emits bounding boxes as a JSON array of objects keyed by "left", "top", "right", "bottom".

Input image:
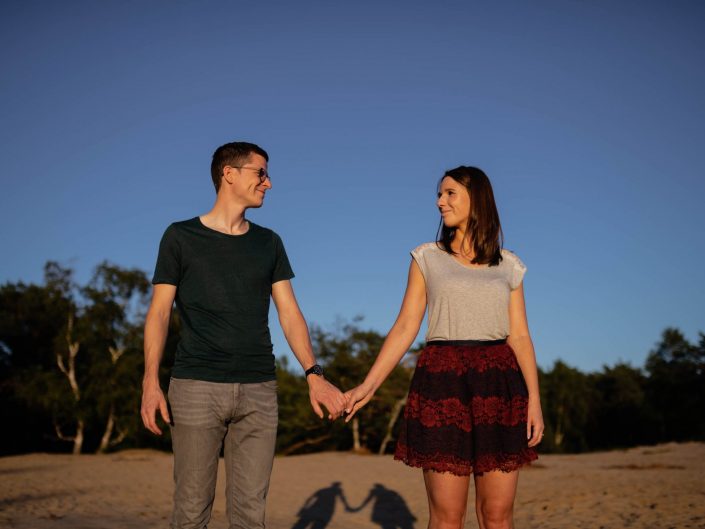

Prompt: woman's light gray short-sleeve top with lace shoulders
[{"left": 411, "top": 242, "right": 526, "bottom": 342}]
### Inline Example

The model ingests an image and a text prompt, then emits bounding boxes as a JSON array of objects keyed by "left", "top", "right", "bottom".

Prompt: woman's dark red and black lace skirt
[{"left": 394, "top": 342, "right": 538, "bottom": 476}]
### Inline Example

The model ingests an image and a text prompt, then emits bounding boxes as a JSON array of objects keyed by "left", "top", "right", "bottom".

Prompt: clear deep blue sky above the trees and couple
[{"left": 0, "top": 1, "right": 705, "bottom": 370}]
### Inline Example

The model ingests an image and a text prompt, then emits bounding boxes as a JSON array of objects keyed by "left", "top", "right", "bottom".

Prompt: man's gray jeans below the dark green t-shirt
[{"left": 169, "top": 378, "right": 278, "bottom": 529}]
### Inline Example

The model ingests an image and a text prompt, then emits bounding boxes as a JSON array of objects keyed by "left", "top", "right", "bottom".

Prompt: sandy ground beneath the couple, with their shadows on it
[{"left": 0, "top": 443, "right": 705, "bottom": 529}]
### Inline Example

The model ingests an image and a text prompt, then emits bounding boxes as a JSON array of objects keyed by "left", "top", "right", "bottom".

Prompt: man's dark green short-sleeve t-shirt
[{"left": 152, "top": 217, "right": 294, "bottom": 382}]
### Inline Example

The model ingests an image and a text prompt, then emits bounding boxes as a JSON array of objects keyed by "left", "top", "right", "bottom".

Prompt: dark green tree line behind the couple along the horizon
[{"left": 0, "top": 262, "right": 705, "bottom": 455}]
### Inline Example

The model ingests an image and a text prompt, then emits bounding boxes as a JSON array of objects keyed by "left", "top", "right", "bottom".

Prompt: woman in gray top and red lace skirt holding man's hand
[{"left": 346, "top": 166, "right": 544, "bottom": 529}]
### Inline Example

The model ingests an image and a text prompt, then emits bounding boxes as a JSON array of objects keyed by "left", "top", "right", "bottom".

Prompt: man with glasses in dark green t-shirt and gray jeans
[{"left": 142, "top": 142, "right": 345, "bottom": 529}]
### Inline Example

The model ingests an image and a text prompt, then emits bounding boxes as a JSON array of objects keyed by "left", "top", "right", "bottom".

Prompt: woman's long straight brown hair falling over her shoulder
[{"left": 436, "top": 165, "right": 504, "bottom": 266}]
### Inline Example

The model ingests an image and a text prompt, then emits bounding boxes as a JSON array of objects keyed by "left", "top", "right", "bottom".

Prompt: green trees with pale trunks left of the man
[{"left": 0, "top": 262, "right": 179, "bottom": 454}]
